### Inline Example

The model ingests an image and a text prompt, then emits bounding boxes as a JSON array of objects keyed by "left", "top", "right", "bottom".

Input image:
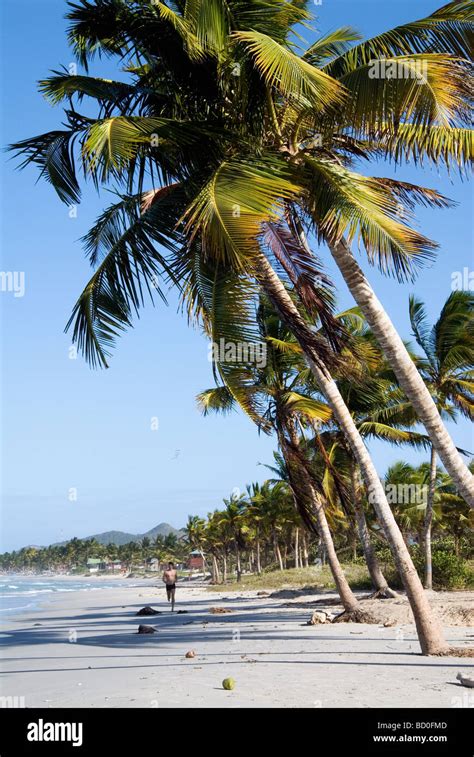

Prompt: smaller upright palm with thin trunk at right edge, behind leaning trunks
[{"left": 409, "top": 291, "right": 474, "bottom": 589}]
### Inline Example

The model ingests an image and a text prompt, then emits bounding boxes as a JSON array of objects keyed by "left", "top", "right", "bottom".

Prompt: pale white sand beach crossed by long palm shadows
[{"left": 0, "top": 582, "right": 474, "bottom": 708}]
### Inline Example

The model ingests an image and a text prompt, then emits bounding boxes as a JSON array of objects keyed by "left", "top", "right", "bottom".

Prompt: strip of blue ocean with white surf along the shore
[{"left": 0, "top": 575, "right": 146, "bottom": 618}]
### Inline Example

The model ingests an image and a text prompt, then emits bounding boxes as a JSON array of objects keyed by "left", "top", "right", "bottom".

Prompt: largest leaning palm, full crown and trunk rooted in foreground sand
[{"left": 10, "top": 0, "right": 462, "bottom": 652}]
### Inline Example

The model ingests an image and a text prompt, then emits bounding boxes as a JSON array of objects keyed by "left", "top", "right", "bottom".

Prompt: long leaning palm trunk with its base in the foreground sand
[{"left": 257, "top": 255, "right": 447, "bottom": 654}]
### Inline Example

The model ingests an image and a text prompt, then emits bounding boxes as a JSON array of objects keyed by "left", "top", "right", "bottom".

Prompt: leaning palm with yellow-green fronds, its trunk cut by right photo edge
[{"left": 295, "top": 1, "right": 474, "bottom": 507}]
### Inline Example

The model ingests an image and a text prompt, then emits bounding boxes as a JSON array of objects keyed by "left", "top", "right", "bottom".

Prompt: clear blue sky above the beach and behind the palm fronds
[{"left": 0, "top": 0, "right": 474, "bottom": 550}]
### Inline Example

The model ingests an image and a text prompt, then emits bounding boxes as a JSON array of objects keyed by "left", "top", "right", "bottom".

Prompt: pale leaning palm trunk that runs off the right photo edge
[{"left": 329, "top": 239, "right": 474, "bottom": 507}]
